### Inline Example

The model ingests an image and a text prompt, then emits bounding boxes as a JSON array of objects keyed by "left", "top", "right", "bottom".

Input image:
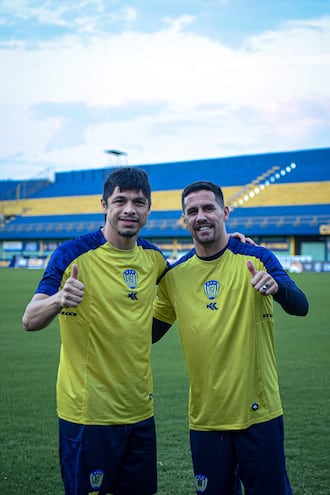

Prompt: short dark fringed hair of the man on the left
[{"left": 103, "top": 167, "right": 151, "bottom": 206}]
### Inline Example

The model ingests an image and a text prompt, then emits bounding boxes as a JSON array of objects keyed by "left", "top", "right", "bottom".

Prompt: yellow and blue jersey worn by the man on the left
[{"left": 36, "top": 230, "right": 166, "bottom": 425}]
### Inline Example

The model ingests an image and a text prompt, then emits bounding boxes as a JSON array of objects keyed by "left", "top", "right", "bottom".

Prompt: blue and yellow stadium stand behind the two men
[{"left": 0, "top": 148, "right": 330, "bottom": 266}]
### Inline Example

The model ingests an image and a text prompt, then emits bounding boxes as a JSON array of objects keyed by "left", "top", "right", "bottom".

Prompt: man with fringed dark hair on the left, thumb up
[{"left": 23, "top": 167, "right": 166, "bottom": 495}]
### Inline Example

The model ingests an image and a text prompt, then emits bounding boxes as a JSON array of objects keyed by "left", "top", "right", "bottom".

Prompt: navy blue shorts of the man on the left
[{"left": 59, "top": 418, "right": 157, "bottom": 495}]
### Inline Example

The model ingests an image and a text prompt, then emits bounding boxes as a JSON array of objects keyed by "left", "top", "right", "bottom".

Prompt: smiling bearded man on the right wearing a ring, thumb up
[{"left": 153, "top": 181, "right": 308, "bottom": 495}]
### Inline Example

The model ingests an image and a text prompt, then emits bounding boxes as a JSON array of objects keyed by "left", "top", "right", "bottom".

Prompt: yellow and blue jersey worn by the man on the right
[{"left": 154, "top": 238, "right": 308, "bottom": 431}]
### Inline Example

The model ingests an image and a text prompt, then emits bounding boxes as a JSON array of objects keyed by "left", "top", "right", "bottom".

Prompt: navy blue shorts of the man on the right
[{"left": 190, "top": 416, "right": 292, "bottom": 495}]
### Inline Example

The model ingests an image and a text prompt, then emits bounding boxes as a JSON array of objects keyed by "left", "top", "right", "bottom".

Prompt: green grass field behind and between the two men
[{"left": 0, "top": 269, "right": 330, "bottom": 495}]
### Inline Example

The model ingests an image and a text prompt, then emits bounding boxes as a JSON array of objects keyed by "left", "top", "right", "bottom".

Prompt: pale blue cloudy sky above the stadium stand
[{"left": 0, "top": 0, "right": 330, "bottom": 180}]
